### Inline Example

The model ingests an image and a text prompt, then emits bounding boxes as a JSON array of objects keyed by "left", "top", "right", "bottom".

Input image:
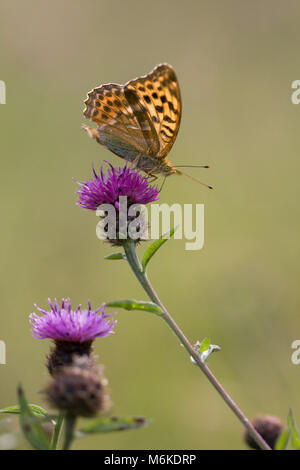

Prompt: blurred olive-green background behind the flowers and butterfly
[{"left": 0, "top": 0, "right": 300, "bottom": 449}]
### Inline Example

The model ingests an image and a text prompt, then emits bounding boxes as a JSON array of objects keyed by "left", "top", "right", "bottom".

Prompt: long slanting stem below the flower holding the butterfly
[{"left": 123, "top": 239, "right": 271, "bottom": 450}]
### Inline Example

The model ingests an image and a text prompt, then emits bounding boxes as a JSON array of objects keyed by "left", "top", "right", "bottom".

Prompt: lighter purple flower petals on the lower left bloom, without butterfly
[{"left": 30, "top": 299, "right": 116, "bottom": 343}]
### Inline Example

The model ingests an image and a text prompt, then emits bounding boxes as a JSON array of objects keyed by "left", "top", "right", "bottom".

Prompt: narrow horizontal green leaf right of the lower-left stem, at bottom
[{"left": 76, "top": 416, "right": 149, "bottom": 437}]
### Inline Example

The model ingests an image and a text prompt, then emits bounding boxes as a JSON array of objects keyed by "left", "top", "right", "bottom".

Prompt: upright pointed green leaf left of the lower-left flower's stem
[{"left": 18, "top": 386, "right": 50, "bottom": 450}]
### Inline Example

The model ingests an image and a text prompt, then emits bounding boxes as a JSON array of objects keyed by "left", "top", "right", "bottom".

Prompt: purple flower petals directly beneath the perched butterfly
[{"left": 75, "top": 163, "right": 159, "bottom": 211}]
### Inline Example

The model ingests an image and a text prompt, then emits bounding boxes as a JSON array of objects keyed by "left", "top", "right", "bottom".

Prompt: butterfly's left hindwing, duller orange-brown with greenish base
[{"left": 84, "top": 83, "right": 159, "bottom": 161}]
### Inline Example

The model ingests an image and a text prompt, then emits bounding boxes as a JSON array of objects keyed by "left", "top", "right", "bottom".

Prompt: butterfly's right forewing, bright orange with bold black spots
[{"left": 124, "top": 64, "right": 182, "bottom": 159}]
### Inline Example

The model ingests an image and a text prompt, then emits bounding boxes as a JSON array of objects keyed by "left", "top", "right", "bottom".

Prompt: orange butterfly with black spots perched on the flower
[{"left": 83, "top": 63, "right": 212, "bottom": 187}]
